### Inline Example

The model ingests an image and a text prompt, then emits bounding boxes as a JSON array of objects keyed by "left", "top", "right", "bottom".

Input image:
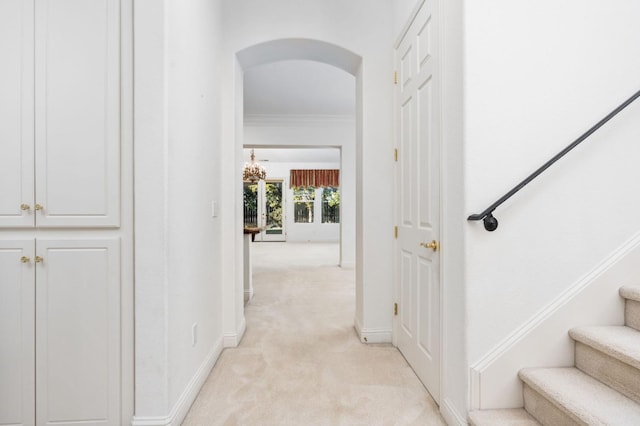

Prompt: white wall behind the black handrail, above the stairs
[{"left": 459, "top": 0, "right": 640, "bottom": 412}]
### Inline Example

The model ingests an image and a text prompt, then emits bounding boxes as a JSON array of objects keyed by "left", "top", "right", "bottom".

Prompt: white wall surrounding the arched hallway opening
[{"left": 222, "top": 0, "right": 393, "bottom": 341}]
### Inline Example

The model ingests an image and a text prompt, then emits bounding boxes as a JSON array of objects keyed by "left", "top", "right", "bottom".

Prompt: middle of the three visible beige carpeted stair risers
[{"left": 575, "top": 342, "right": 640, "bottom": 403}]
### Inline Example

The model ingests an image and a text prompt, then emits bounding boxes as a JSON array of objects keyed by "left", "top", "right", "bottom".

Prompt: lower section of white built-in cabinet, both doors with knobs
[{"left": 0, "top": 239, "right": 121, "bottom": 425}]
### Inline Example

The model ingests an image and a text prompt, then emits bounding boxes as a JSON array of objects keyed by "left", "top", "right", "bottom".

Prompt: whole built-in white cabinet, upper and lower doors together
[{"left": 0, "top": 0, "right": 126, "bottom": 426}]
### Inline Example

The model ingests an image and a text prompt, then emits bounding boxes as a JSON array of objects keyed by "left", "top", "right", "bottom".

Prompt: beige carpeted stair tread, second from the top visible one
[{"left": 569, "top": 326, "right": 640, "bottom": 369}]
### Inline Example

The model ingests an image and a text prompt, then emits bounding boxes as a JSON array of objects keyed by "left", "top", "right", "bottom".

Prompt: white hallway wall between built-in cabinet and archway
[{"left": 134, "top": 0, "right": 222, "bottom": 425}]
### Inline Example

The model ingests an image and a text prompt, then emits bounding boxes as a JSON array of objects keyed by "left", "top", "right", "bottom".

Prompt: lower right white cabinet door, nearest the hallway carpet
[{"left": 36, "top": 239, "right": 121, "bottom": 426}]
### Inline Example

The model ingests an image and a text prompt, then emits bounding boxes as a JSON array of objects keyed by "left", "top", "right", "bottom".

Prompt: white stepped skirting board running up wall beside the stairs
[{"left": 469, "top": 233, "right": 640, "bottom": 410}]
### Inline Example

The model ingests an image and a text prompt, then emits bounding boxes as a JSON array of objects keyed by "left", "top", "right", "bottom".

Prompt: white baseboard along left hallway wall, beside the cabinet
[{"left": 131, "top": 339, "right": 223, "bottom": 426}]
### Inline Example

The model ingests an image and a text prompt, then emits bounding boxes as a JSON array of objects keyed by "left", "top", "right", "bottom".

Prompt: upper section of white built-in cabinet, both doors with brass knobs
[{"left": 0, "top": 0, "right": 120, "bottom": 227}]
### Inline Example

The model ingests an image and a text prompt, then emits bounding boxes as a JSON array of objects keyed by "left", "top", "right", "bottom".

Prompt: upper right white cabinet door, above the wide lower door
[{"left": 35, "top": 0, "right": 120, "bottom": 227}]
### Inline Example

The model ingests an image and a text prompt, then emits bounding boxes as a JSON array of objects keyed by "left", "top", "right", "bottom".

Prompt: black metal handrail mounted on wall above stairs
[{"left": 467, "top": 90, "right": 640, "bottom": 231}]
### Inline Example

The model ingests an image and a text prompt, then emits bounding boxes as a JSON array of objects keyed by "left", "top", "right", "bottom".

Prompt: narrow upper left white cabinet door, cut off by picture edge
[{"left": 0, "top": 0, "right": 34, "bottom": 227}]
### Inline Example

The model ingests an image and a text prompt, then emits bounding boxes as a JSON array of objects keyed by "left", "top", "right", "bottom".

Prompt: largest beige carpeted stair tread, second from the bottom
[{"left": 518, "top": 368, "right": 640, "bottom": 426}]
